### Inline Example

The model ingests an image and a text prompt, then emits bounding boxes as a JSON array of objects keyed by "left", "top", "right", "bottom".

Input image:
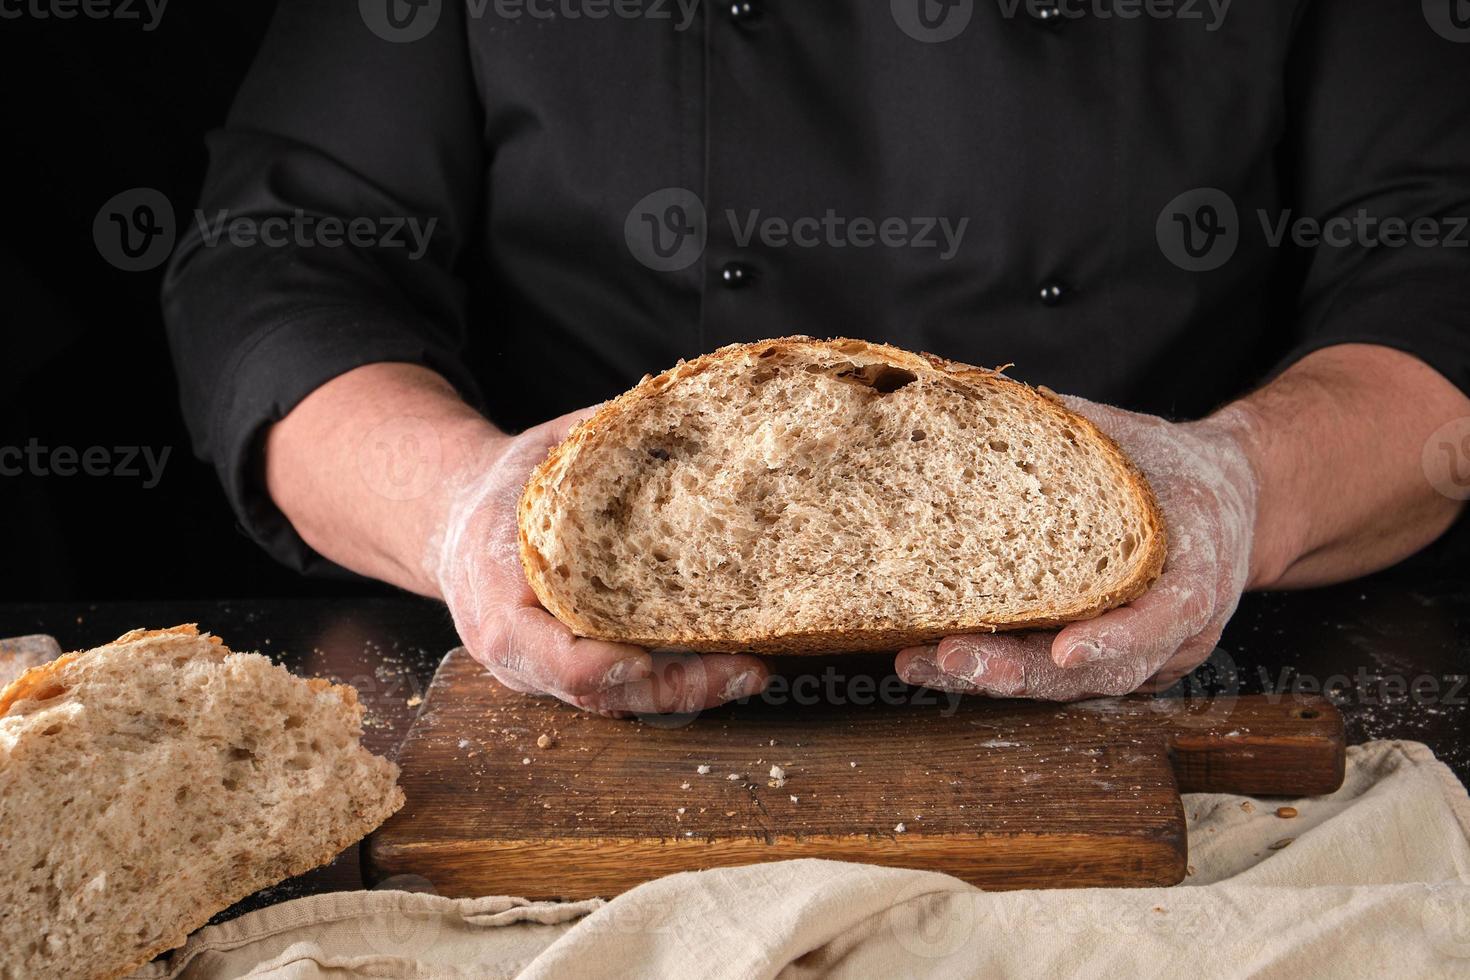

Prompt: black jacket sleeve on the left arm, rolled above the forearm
[{"left": 163, "top": 0, "right": 482, "bottom": 570}]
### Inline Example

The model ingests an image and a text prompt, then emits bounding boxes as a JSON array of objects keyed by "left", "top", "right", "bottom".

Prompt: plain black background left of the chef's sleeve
[{"left": 0, "top": 11, "right": 387, "bottom": 601}]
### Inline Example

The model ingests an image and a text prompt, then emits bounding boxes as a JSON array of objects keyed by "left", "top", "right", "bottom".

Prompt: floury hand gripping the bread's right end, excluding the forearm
[{"left": 898, "top": 398, "right": 1258, "bottom": 701}]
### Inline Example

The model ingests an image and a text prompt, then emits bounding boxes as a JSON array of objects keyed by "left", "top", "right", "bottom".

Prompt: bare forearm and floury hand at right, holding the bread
[{"left": 898, "top": 344, "right": 1470, "bottom": 701}]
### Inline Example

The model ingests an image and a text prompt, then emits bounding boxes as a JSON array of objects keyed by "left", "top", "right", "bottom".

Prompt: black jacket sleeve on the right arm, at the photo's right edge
[{"left": 1275, "top": 0, "right": 1470, "bottom": 560}]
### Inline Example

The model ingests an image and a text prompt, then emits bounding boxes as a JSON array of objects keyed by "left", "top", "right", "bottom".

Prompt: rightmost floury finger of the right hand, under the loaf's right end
[{"left": 1051, "top": 572, "right": 1214, "bottom": 674}]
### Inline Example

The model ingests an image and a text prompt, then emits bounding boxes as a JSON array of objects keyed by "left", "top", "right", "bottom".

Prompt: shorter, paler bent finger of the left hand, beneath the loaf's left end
[{"left": 484, "top": 605, "right": 653, "bottom": 699}]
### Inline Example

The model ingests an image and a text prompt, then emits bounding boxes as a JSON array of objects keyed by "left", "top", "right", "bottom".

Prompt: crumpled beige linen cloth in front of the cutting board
[{"left": 134, "top": 742, "right": 1470, "bottom": 980}]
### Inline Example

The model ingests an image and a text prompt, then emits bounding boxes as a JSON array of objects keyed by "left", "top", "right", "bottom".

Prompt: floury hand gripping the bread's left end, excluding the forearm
[{"left": 426, "top": 411, "right": 766, "bottom": 714}]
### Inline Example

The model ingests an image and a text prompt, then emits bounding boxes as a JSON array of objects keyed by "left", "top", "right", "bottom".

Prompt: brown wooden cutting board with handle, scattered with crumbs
[{"left": 365, "top": 651, "right": 1344, "bottom": 899}]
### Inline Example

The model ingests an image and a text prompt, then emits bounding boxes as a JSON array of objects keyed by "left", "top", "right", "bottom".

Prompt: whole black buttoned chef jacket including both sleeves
[{"left": 163, "top": 0, "right": 1470, "bottom": 567}]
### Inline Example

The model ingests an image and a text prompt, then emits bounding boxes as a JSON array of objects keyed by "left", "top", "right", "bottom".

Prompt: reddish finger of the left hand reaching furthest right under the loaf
[{"left": 581, "top": 654, "right": 770, "bottom": 714}]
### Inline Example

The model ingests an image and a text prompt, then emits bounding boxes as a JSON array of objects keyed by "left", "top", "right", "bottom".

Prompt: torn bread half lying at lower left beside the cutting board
[{"left": 0, "top": 626, "right": 403, "bottom": 980}]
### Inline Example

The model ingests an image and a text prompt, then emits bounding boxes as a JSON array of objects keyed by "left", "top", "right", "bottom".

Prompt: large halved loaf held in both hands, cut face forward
[{"left": 519, "top": 336, "right": 1164, "bottom": 652}]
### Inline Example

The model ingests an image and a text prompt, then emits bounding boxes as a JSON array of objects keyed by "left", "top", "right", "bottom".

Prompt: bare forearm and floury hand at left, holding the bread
[{"left": 266, "top": 363, "right": 766, "bottom": 714}]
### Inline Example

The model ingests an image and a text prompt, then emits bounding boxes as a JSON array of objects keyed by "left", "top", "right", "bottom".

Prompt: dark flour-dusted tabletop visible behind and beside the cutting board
[{"left": 0, "top": 576, "right": 1470, "bottom": 918}]
